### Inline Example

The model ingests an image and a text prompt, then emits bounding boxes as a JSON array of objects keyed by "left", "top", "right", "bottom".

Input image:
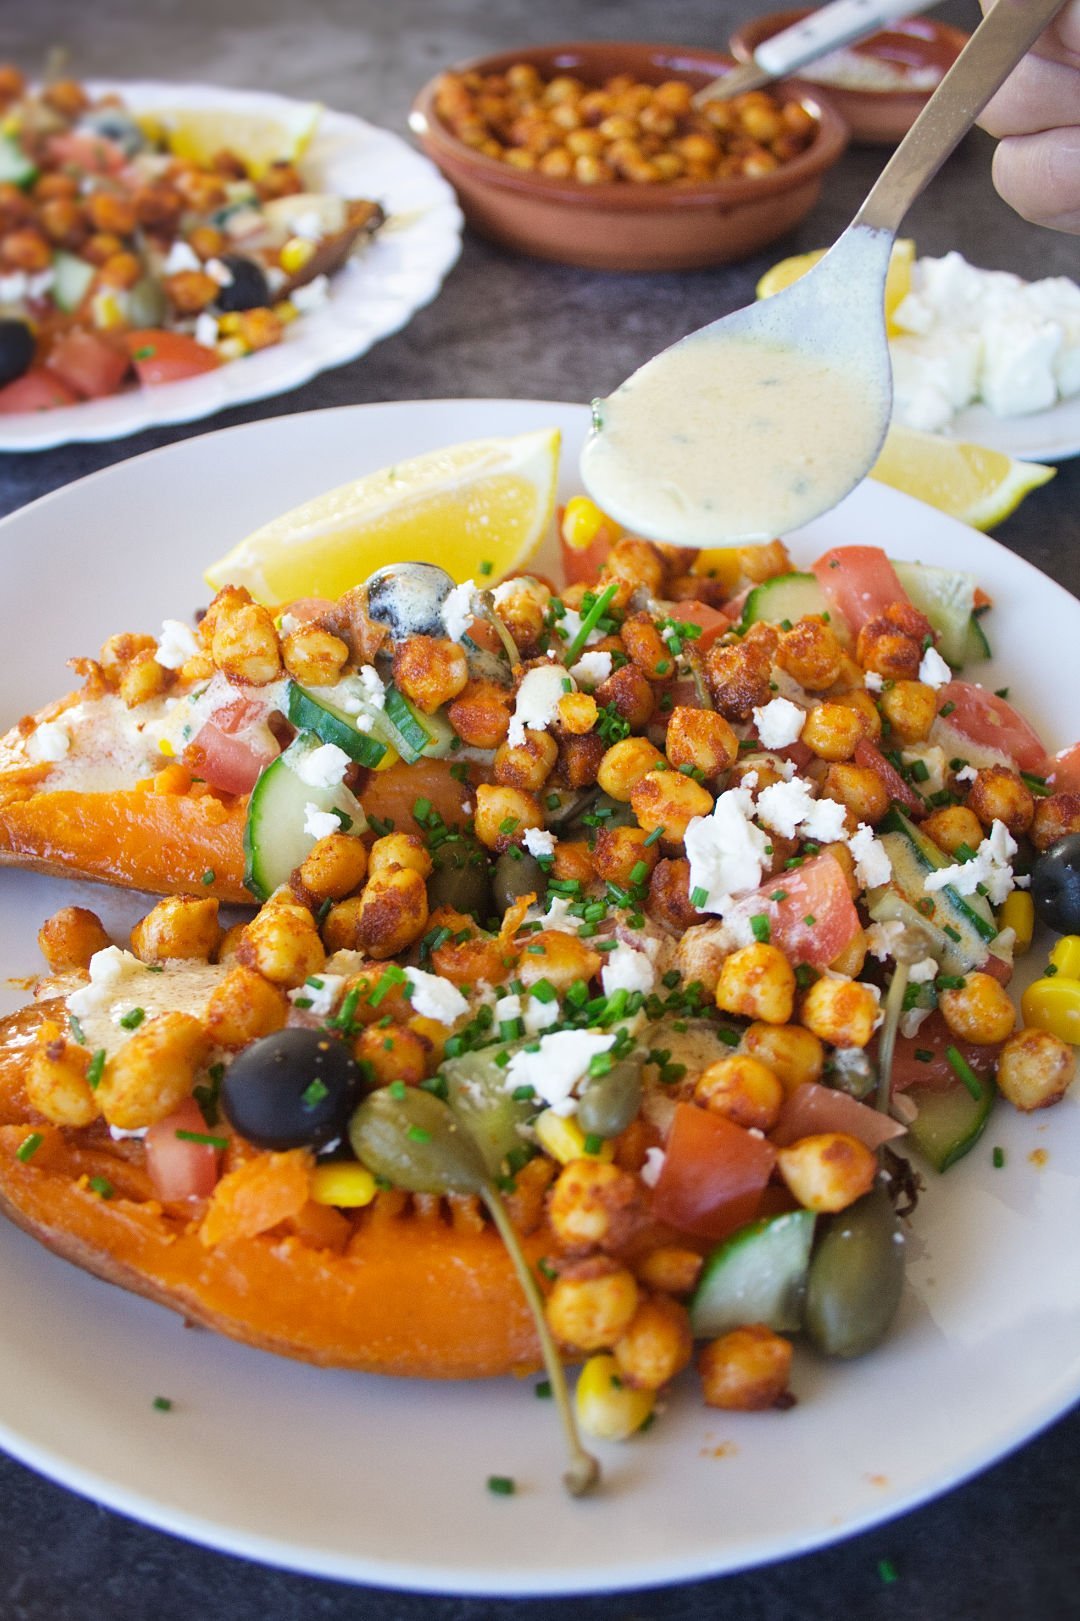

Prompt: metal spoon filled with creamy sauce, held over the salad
[{"left": 581, "top": 0, "right": 1062, "bottom": 546}]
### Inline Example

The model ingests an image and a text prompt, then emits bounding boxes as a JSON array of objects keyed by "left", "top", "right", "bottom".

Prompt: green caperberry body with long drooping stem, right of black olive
[{"left": 349, "top": 1086, "right": 488, "bottom": 1193}]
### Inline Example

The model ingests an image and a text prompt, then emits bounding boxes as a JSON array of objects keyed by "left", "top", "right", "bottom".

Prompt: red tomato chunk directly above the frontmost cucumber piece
[{"left": 650, "top": 1104, "right": 777, "bottom": 1238}]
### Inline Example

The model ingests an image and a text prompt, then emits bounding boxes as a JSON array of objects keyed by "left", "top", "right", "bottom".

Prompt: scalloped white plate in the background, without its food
[{"left": 0, "top": 81, "right": 462, "bottom": 451}]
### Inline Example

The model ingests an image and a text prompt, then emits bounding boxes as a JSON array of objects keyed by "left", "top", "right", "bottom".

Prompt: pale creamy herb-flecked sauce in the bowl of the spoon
[{"left": 582, "top": 334, "right": 881, "bottom": 546}]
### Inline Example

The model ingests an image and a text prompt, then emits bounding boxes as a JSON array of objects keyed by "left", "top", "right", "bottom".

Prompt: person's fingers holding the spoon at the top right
[{"left": 979, "top": 0, "right": 1080, "bottom": 233}]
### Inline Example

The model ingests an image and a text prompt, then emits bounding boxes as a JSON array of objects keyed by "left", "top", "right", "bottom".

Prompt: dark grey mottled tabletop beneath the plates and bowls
[{"left": 0, "top": 0, "right": 1080, "bottom": 1621}]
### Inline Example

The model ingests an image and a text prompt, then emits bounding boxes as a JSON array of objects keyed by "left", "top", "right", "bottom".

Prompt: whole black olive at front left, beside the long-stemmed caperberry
[{"left": 221, "top": 1028, "right": 362, "bottom": 1149}]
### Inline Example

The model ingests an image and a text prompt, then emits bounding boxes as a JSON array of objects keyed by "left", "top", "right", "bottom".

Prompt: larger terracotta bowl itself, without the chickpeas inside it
[{"left": 409, "top": 42, "right": 846, "bottom": 271}]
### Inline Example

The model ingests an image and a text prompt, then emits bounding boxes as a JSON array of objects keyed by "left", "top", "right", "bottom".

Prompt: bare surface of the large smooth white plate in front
[{"left": 0, "top": 400, "right": 1080, "bottom": 1593}]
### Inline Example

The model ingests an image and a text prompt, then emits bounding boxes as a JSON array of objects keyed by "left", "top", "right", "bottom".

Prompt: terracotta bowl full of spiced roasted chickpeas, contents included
[{"left": 410, "top": 42, "right": 846, "bottom": 271}]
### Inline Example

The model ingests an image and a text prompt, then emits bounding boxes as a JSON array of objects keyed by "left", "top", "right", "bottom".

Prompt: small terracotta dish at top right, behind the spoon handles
[{"left": 730, "top": 6, "right": 968, "bottom": 146}]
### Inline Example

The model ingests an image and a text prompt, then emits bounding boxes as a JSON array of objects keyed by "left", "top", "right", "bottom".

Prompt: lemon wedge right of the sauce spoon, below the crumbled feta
[{"left": 871, "top": 426, "right": 1057, "bottom": 528}]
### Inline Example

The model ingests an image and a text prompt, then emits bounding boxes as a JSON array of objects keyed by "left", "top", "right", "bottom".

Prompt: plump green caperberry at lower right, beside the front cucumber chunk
[{"left": 803, "top": 1187, "right": 905, "bottom": 1357}]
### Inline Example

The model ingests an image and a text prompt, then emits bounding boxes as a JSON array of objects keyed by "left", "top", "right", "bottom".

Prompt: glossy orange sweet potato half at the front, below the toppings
[{"left": 0, "top": 1002, "right": 553, "bottom": 1379}]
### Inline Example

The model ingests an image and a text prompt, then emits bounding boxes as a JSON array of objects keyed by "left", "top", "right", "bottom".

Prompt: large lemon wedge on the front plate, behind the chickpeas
[{"left": 206, "top": 428, "right": 559, "bottom": 603}]
